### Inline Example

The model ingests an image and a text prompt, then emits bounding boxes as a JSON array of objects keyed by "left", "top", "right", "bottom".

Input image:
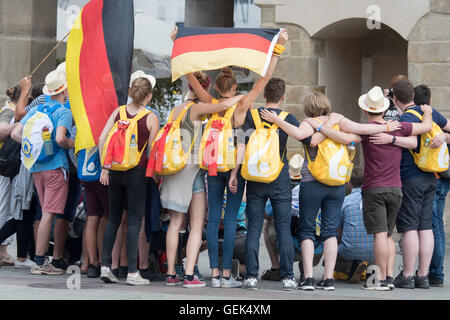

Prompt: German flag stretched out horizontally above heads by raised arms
[{"left": 172, "top": 28, "right": 280, "bottom": 81}]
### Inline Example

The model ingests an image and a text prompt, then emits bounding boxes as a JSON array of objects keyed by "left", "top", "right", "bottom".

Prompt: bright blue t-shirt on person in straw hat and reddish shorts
[{"left": 20, "top": 102, "right": 72, "bottom": 173}]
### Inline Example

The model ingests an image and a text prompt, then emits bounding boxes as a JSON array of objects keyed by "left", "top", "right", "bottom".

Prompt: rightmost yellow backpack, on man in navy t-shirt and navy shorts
[{"left": 405, "top": 110, "right": 449, "bottom": 172}]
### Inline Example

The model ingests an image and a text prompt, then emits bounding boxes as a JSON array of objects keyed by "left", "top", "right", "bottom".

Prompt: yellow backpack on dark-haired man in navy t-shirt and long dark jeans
[{"left": 241, "top": 109, "right": 288, "bottom": 183}]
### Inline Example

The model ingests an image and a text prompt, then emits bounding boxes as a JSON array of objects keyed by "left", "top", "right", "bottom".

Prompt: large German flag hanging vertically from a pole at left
[{"left": 66, "top": 0, "right": 134, "bottom": 152}]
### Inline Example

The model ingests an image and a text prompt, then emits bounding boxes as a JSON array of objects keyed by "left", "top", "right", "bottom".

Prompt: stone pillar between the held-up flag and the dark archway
[{"left": 256, "top": 0, "right": 325, "bottom": 158}]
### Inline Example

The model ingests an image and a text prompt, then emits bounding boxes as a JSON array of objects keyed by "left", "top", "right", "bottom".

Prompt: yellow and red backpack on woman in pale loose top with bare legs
[{"left": 146, "top": 102, "right": 195, "bottom": 177}]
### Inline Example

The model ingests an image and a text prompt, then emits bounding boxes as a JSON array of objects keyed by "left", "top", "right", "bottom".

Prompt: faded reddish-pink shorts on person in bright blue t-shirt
[{"left": 33, "top": 168, "right": 69, "bottom": 214}]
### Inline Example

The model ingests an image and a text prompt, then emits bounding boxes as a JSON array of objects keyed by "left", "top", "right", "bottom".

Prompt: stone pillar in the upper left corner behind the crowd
[{"left": 0, "top": 0, "right": 57, "bottom": 104}]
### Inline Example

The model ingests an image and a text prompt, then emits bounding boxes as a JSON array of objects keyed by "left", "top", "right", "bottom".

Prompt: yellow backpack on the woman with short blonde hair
[{"left": 305, "top": 119, "right": 351, "bottom": 186}]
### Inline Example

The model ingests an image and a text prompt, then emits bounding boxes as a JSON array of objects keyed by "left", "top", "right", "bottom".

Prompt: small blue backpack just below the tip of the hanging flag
[{"left": 78, "top": 146, "right": 102, "bottom": 182}]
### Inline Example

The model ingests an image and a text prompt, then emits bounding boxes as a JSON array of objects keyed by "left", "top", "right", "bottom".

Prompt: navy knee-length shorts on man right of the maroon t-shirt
[{"left": 397, "top": 175, "right": 437, "bottom": 233}]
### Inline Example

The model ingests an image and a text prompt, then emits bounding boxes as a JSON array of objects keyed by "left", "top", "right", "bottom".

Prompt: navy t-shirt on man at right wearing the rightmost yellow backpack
[{"left": 400, "top": 106, "right": 447, "bottom": 180}]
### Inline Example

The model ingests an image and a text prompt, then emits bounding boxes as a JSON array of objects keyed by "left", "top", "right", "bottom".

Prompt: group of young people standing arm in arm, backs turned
[{"left": 0, "top": 26, "right": 450, "bottom": 290}]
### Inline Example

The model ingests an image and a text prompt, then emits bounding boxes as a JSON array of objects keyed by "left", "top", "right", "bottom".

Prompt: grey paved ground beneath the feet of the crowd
[{"left": 0, "top": 236, "right": 450, "bottom": 300}]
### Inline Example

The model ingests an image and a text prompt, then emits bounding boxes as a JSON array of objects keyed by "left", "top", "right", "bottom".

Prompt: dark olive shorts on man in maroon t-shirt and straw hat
[{"left": 362, "top": 187, "right": 402, "bottom": 237}]
